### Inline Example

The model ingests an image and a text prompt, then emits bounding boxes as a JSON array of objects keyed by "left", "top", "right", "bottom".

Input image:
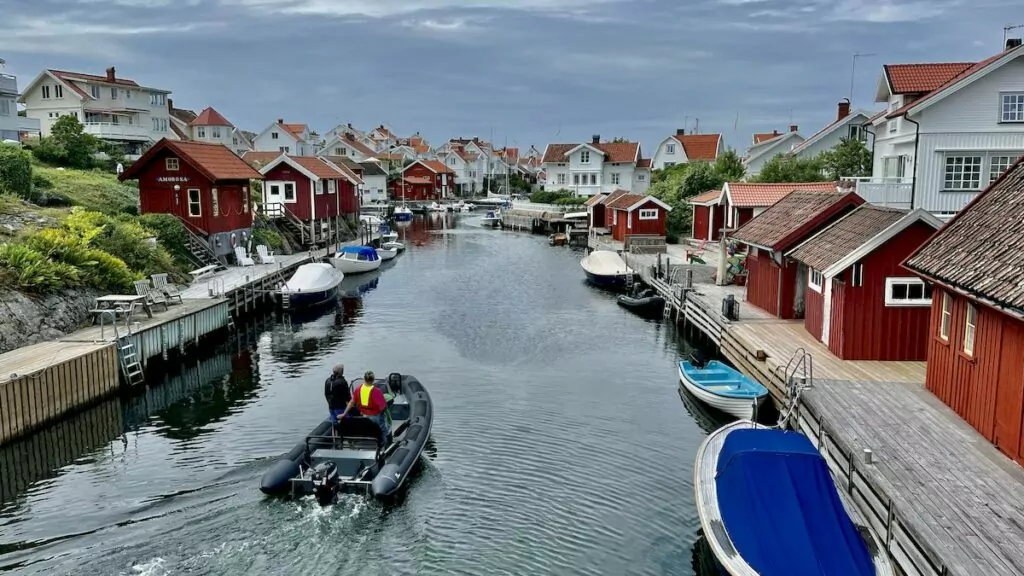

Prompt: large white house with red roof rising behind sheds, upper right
[{"left": 857, "top": 39, "right": 1024, "bottom": 219}]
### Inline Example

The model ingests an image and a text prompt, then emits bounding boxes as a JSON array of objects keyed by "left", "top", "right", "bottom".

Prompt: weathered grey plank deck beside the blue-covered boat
[{"left": 802, "top": 377, "right": 1024, "bottom": 576}]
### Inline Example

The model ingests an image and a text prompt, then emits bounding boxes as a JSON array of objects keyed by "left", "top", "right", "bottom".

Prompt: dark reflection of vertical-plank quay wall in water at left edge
[{"left": 0, "top": 398, "right": 124, "bottom": 504}]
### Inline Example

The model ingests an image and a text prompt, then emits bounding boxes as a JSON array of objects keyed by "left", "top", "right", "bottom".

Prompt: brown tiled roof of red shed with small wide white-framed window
[{"left": 790, "top": 204, "right": 908, "bottom": 271}]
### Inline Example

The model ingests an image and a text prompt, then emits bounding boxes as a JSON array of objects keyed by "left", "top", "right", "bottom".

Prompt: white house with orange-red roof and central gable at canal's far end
[{"left": 542, "top": 135, "right": 650, "bottom": 196}]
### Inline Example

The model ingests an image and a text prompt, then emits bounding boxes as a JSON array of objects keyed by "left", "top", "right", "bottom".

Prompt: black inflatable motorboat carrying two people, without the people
[{"left": 260, "top": 373, "right": 433, "bottom": 505}]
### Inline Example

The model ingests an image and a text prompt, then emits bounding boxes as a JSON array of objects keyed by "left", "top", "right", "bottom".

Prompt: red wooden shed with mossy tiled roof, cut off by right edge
[{"left": 903, "top": 154, "right": 1024, "bottom": 464}]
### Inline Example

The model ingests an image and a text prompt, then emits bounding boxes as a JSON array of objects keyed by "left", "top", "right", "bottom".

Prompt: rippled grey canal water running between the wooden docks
[{"left": 0, "top": 215, "right": 733, "bottom": 575}]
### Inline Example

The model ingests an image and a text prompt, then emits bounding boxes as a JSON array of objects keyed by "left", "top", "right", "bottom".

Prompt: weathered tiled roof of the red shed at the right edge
[{"left": 903, "top": 154, "right": 1024, "bottom": 317}]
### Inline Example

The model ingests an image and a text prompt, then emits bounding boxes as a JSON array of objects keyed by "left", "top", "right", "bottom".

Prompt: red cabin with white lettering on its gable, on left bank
[{"left": 118, "top": 138, "right": 262, "bottom": 256}]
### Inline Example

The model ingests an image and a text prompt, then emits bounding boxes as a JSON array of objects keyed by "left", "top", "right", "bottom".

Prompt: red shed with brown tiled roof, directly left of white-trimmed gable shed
[{"left": 729, "top": 191, "right": 864, "bottom": 319}]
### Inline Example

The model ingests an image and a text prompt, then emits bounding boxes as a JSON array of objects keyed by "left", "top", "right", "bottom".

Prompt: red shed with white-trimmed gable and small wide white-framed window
[{"left": 790, "top": 204, "right": 942, "bottom": 361}]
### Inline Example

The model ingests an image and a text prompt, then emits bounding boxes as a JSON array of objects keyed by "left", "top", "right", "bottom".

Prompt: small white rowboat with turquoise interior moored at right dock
[{"left": 679, "top": 360, "right": 768, "bottom": 419}]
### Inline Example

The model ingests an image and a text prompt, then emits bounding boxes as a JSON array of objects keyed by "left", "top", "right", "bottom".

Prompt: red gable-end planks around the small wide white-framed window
[{"left": 828, "top": 222, "right": 935, "bottom": 361}]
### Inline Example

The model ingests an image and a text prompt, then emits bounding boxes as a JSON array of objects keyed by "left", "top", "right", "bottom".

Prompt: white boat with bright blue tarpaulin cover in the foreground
[{"left": 693, "top": 420, "right": 893, "bottom": 576}]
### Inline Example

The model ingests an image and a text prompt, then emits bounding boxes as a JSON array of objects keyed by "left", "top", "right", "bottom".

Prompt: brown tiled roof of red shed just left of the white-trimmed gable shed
[{"left": 729, "top": 190, "right": 864, "bottom": 251}]
